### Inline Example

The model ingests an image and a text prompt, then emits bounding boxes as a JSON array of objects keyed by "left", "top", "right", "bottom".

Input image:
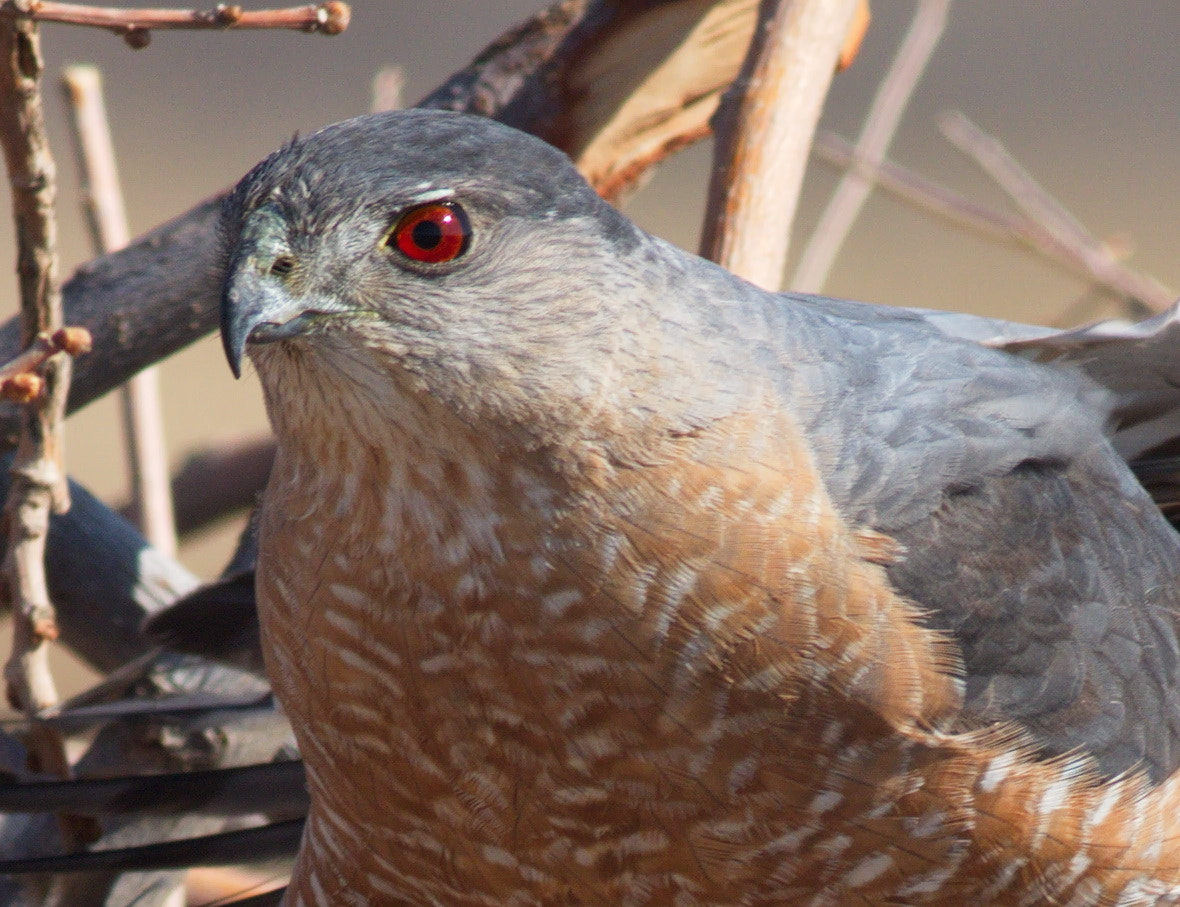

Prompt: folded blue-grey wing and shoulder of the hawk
[{"left": 651, "top": 245, "right": 1180, "bottom": 781}]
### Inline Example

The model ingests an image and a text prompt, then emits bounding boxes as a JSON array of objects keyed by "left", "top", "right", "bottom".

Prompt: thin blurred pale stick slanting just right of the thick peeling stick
[{"left": 791, "top": 0, "right": 950, "bottom": 293}]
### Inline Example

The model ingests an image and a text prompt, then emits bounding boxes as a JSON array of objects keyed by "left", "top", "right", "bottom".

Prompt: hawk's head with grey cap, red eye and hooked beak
[{"left": 222, "top": 111, "right": 647, "bottom": 443}]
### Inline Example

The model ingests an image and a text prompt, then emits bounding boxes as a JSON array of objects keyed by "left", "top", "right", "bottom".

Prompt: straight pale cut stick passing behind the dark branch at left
[{"left": 63, "top": 66, "right": 176, "bottom": 558}]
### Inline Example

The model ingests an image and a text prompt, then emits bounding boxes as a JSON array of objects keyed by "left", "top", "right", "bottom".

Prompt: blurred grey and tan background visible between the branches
[{"left": 0, "top": 0, "right": 1180, "bottom": 660}]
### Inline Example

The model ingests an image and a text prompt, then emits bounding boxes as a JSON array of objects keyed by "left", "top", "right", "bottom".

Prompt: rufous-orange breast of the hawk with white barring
[{"left": 258, "top": 358, "right": 1180, "bottom": 905}]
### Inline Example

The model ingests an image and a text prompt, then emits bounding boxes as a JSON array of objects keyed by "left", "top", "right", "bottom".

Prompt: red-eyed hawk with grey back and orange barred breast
[{"left": 6, "top": 111, "right": 1180, "bottom": 907}]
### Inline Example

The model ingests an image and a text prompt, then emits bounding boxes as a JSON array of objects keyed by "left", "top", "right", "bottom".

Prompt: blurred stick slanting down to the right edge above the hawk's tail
[{"left": 939, "top": 112, "right": 1173, "bottom": 311}]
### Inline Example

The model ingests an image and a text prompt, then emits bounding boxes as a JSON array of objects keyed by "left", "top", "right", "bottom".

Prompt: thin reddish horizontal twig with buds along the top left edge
[{"left": 0, "top": 0, "right": 352, "bottom": 47}]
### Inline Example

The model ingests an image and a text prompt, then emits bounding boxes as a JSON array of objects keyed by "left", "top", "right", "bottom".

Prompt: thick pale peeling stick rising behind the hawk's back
[{"left": 701, "top": 0, "right": 857, "bottom": 289}]
